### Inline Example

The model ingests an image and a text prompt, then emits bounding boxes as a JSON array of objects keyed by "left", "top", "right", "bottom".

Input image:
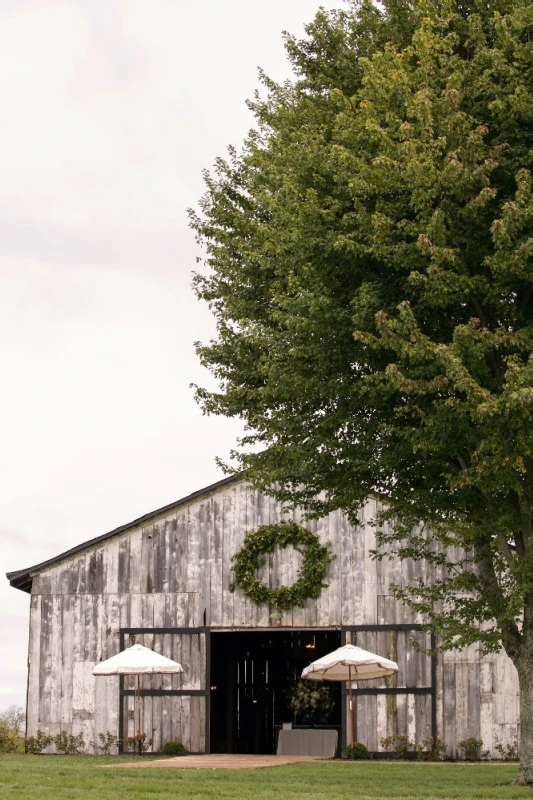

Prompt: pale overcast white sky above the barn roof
[{"left": 0, "top": 0, "right": 342, "bottom": 711}]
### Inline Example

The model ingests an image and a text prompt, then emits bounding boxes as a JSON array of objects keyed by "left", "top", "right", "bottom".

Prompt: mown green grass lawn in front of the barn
[{"left": 0, "top": 755, "right": 533, "bottom": 800}]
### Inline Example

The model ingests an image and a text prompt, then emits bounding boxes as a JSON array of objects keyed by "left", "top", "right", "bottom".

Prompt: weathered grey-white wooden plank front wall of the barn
[{"left": 8, "top": 478, "right": 518, "bottom": 755}]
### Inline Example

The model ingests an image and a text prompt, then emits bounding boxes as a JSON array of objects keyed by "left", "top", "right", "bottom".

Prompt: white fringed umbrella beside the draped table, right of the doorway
[{"left": 302, "top": 644, "right": 398, "bottom": 744}]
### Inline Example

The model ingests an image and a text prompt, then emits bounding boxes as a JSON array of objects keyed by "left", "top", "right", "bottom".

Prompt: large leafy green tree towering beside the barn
[{"left": 192, "top": 0, "right": 533, "bottom": 784}]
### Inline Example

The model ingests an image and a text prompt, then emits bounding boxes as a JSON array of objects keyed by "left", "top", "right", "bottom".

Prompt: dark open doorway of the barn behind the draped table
[{"left": 210, "top": 630, "right": 341, "bottom": 754}]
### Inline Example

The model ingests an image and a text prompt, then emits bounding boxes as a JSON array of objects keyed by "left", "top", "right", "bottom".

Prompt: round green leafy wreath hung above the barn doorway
[{"left": 230, "top": 522, "right": 335, "bottom": 611}]
